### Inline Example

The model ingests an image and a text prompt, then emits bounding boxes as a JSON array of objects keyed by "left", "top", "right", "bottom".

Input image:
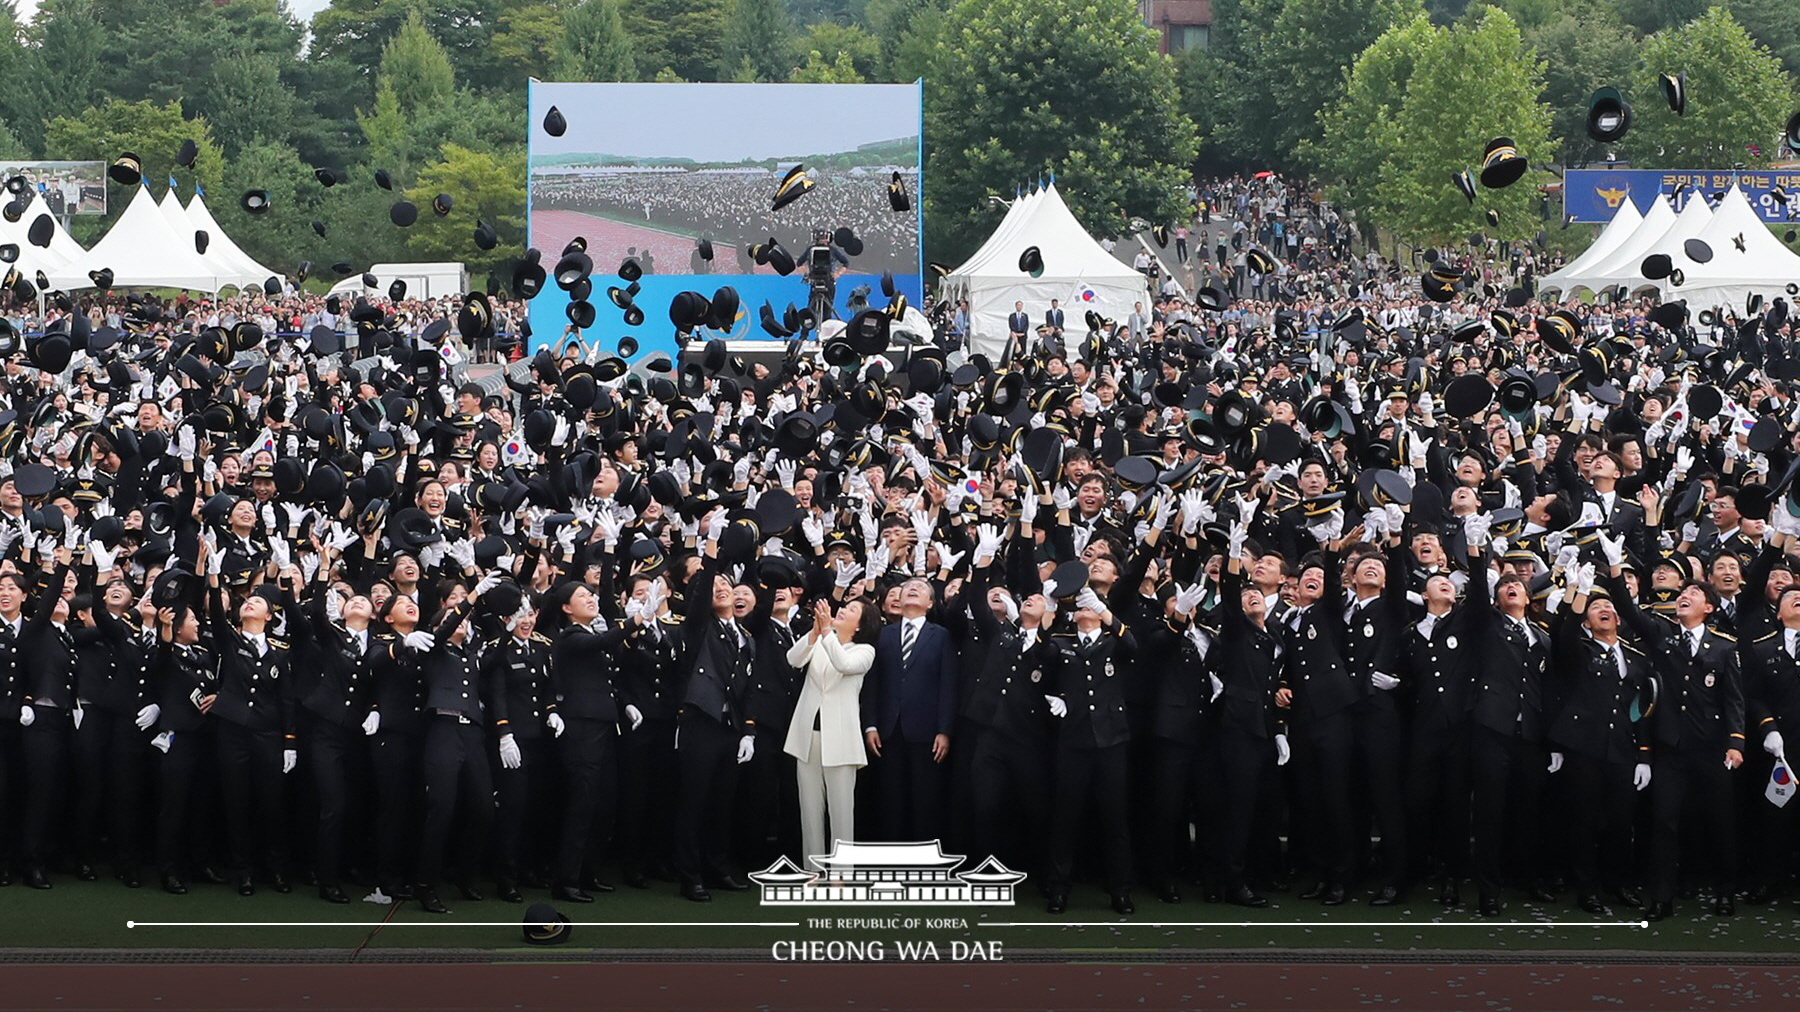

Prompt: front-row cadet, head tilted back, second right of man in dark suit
[{"left": 1044, "top": 576, "right": 1138, "bottom": 915}]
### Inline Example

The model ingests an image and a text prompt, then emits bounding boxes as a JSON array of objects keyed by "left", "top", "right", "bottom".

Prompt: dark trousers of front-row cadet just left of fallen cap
[{"left": 419, "top": 715, "right": 493, "bottom": 888}]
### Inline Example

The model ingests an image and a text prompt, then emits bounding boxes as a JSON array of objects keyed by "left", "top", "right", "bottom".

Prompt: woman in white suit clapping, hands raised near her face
[{"left": 783, "top": 600, "right": 880, "bottom": 872}]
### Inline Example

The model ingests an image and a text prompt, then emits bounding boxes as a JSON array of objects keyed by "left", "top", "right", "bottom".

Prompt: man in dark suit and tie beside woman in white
[{"left": 862, "top": 580, "right": 958, "bottom": 841}]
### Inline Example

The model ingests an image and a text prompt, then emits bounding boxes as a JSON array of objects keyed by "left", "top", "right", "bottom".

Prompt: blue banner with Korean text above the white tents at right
[{"left": 1562, "top": 169, "right": 1800, "bottom": 225}]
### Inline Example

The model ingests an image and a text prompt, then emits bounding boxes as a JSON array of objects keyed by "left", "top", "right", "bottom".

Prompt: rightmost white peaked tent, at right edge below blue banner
[{"left": 1658, "top": 184, "right": 1800, "bottom": 312}]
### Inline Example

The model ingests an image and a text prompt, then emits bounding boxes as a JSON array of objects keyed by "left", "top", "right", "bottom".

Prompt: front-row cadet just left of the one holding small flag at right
[{"left": 1600, "top": 535, "right": 1744, "bottom": 920}]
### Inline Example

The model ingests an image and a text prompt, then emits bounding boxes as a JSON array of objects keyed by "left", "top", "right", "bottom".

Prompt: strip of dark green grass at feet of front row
[{"left": 0, "top": 879, "right": 1800, "bottom": 958}]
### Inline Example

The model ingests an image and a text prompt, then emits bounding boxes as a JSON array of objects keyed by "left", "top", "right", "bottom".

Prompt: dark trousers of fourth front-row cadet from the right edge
[{"left": 1469, "top": 724, "right": 1550, "bottom": 897}]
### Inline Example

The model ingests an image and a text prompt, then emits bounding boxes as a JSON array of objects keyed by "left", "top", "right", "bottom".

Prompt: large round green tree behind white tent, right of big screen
[{"left": 925, "top": 0, "right": 1195, "bottom": 259}]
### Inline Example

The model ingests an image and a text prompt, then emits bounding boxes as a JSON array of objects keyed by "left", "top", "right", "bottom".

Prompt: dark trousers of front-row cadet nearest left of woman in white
[{"left": 675, "top": 709, "right": 742, "bottom": 888}]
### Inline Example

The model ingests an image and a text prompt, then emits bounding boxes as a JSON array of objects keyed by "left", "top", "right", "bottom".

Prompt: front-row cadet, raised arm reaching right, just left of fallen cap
[{"left": 403, "top": 576, "right": 499, "bottom": 913}]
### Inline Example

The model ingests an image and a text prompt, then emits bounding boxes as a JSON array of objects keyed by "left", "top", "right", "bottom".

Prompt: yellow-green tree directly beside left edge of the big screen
[{"left": 407, "top": 144, "right": 526, "bottom": 265}]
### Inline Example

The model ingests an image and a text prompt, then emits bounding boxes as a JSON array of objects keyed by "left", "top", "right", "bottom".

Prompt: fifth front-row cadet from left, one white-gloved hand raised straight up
[{"left": 207, "top": 553, "right": 299, "bottom": 897}]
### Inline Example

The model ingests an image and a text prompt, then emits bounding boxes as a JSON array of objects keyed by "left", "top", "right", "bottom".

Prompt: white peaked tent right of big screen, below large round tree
[{"left": 945, "top": 184, "right": 1148, "bottom": 360}]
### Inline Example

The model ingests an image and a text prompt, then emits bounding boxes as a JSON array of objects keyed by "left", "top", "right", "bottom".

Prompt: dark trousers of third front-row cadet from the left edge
[{"left": 74, "top": 706, "right": 149, "bottom": 870}]
